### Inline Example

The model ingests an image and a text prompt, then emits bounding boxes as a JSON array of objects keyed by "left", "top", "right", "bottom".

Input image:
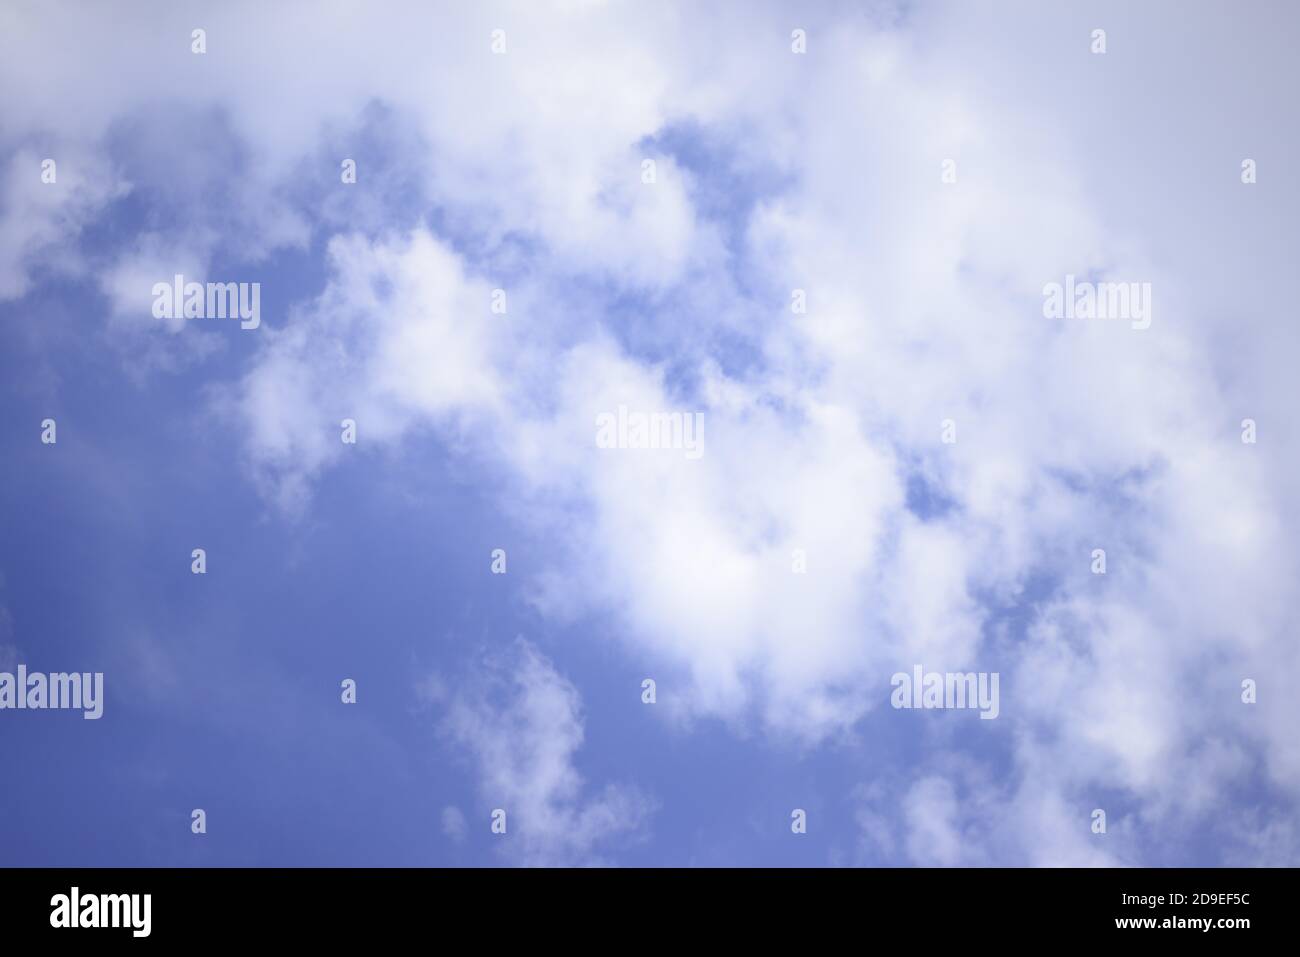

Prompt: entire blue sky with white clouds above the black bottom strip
[{"left": 0, "top": 0, "right": 1300, "bottom": 866}]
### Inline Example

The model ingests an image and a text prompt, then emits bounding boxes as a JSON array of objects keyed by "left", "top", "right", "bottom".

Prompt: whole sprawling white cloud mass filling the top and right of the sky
[{"left": 0, "top": 4, "right": 1300, "bottom": 863}]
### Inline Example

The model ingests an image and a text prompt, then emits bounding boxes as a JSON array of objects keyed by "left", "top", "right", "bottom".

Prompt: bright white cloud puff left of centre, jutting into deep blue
[{"left": 218, "top": 230, "right": 504, "bottom": 511}]
